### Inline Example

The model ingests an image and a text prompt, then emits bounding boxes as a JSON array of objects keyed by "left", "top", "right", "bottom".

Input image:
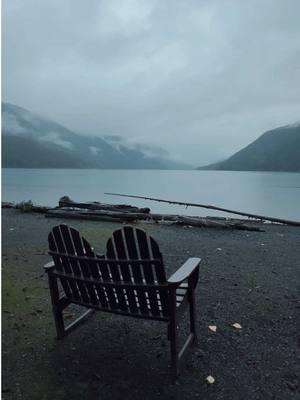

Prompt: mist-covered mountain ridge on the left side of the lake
[{"left": 2, "top": 102, "right": 191, "bottom": 169}]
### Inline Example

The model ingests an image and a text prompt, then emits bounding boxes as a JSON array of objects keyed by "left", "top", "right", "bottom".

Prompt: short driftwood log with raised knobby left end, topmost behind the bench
[{"left": 58, "top": 196, "right": 150, "bottom": 214}]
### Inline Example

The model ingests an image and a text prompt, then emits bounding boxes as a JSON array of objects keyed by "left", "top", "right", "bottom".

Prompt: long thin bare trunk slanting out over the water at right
[{"left": 104, "top": 193, "right": 300, "bottom": 226}]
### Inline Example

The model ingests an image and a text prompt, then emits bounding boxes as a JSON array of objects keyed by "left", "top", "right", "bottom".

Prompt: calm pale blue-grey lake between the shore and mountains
[{"left": 2, "top": 168, "right": 300, "bottom": 220}]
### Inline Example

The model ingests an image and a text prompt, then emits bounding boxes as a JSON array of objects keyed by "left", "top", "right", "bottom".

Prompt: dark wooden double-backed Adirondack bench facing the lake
[{"left": 44, "top": 225, "right": 201, "bottom": 376}]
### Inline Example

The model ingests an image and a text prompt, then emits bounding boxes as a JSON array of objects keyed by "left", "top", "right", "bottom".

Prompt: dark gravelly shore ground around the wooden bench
[{"left": 2, "top": 209, "right": 300, "bottom": 400}]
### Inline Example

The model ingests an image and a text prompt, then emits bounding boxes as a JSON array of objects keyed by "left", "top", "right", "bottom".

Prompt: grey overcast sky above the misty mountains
[{"left": 2, "top": 0, "right": 300, "bottom": 165}]
